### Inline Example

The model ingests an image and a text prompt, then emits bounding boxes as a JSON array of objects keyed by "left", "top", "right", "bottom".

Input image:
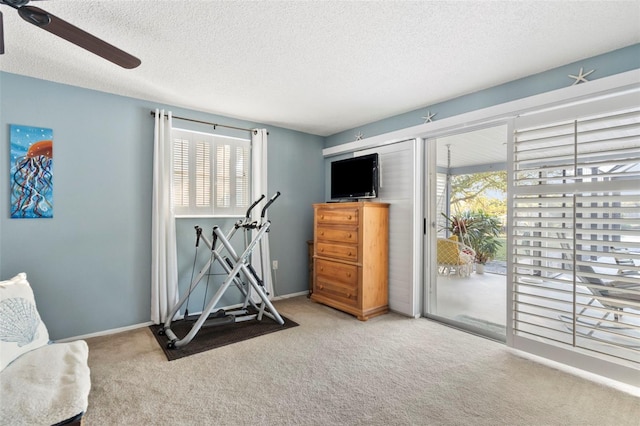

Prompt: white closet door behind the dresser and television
[{"left": 355, "top": 139, "right": 422, "bottom": 316}]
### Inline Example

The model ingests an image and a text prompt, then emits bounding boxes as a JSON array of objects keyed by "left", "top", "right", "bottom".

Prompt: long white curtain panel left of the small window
[{"left": 151, "top": 109, "right": 178, "bottom": 324}]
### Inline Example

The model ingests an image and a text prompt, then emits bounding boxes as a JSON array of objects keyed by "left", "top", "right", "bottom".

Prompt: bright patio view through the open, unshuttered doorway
[{"left": 425, "top": 125, "right": 507, "bottom": 341}]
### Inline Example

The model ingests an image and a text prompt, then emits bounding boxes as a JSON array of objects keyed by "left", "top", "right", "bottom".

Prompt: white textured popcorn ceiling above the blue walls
[{"left": 0, "top": 0, "right": 640, "bottom": 136}]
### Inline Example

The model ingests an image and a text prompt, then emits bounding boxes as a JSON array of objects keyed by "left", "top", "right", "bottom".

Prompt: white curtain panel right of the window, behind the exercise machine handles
[{"left": 251, "top": 129, "right": 274, "bottom": 302}]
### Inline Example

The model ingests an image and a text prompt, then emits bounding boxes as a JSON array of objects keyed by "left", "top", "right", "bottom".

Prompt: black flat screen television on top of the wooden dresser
[{"left": 331, "top": 153, "right": 379, "bottom": 200}]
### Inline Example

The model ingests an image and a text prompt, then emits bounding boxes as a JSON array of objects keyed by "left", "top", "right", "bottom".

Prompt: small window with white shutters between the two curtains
[{"left": 171, "top": 129, "right": 251, "bottom": 216}]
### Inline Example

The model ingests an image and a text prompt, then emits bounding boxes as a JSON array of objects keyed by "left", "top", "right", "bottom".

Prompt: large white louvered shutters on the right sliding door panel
[{"left": 510, "top": 103, "right": 640, "bottom": 367}]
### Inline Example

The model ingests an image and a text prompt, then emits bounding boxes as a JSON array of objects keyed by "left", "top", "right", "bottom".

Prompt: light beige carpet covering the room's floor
[{"left": 85, "top": 297, "right": 640, "bottom": 426}]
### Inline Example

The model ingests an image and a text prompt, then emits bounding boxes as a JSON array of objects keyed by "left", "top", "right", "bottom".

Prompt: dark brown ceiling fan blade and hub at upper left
[{"left": 0, "top": 0, "right": 140, "bottom": 69}]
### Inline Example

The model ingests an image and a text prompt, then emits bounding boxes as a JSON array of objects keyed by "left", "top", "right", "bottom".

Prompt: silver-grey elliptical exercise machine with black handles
[{"left": 159, "top": 192, "right": 284, "bottom": 349}]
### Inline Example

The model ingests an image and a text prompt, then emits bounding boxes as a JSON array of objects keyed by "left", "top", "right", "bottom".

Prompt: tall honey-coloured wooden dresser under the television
[{"left": 311, "top": 202, "right": 389, "bottom": 321}]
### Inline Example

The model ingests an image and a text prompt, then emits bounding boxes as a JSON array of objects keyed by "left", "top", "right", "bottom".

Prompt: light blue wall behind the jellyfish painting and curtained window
[{"left": 0, "top": 72, "right": 324, "bottom": 339}]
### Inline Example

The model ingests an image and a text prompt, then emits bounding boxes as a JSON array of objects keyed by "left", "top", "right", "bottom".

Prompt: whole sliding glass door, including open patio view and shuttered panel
[{"left": 424, "top": 89, "right": 640, "bottom": 386}]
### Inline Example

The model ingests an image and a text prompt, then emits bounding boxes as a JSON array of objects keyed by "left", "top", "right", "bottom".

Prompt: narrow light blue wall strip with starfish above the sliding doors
[{"left": 325, "top": 44, "right": 640, "bottom": 148}]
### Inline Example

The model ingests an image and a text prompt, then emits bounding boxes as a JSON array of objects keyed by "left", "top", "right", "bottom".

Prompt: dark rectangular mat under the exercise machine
[{"left": 149, "top": 315, "right": 299, "bottom": 361}]
